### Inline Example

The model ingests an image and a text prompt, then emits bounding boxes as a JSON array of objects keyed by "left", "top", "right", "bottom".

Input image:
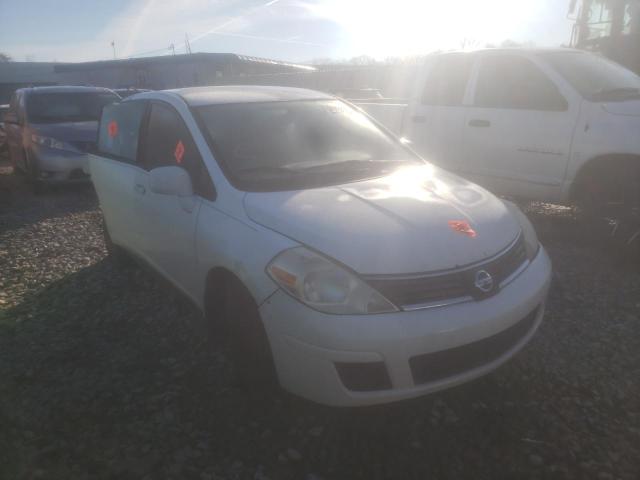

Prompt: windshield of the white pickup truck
[{"left": 543, "top": 52, "right": 640, "bottom": 101}]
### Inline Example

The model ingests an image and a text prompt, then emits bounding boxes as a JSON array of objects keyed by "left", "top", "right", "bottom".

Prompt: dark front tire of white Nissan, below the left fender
[{"left": 208, "top": 278, "right": 278, "bottom": 393}]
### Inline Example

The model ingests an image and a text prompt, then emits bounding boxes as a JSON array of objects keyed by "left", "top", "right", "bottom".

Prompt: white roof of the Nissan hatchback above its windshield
[{"left": 168, "top": 85, "right": 334, "bottom": 107}]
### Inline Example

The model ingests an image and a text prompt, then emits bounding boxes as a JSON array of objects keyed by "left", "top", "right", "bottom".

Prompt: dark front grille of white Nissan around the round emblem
[{"left": 363, "top": 235, "right": 527, "bottom": 307}]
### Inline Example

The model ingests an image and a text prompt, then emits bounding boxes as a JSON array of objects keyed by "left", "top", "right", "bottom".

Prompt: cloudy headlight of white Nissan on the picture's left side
[{"left": 267, "top": 247, "right": 398, "bottom": 315}]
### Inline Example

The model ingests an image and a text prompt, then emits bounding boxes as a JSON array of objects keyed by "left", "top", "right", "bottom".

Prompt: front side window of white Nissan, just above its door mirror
[{"left": 143, "top": 103, "right": 215, "bottom": 200}]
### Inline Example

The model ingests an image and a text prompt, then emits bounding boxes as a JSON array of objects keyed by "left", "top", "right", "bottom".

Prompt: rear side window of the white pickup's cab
[{"left": 422, "top": 54, "right": 473, "bottom": 106}]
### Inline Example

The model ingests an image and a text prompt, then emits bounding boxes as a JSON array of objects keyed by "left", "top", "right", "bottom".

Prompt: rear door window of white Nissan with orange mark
[{"left": 98, "top": 100, "right": 147, "bottom": 163}]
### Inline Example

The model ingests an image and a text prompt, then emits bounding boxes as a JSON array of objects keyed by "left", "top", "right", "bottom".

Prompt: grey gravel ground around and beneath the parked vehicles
[{"left": 0, "top": 162, "right": 640, "bottom": 480}]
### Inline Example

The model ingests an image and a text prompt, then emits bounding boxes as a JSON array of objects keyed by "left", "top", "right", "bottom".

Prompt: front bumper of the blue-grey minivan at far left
[{"left": 31, "top": 145, "right": 90, "bottom": 183}]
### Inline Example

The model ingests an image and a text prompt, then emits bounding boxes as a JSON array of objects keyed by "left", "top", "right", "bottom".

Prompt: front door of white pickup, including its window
[{"left": 460, "top": 53, "right": 579, "bottom": 198}]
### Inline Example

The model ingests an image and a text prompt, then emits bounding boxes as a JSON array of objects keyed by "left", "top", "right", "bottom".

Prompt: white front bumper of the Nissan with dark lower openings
[{"left": 260, "top": 247, "right": 551, "bottom": 406}]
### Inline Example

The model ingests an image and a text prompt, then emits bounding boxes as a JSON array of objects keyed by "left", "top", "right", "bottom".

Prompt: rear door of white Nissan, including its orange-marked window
[{"left": 89, "top": 100, "right": 148, "bottom": 253}]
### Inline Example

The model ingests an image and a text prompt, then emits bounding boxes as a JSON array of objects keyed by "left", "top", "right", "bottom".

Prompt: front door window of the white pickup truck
[{"left": 475, "top": 56, "right": 568, "bottom": 111}]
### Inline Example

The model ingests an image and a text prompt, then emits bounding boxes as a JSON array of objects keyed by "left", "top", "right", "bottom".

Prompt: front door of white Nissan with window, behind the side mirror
[{"left": 134, "top": 100, "right": 214, "bottom": 293}]
